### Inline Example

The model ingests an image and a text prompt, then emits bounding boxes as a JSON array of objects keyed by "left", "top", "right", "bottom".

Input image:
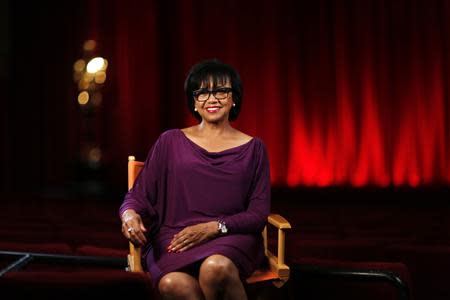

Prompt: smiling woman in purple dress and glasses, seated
[{"left": 120, "top": 60, "right": 270, "bottom": 299}]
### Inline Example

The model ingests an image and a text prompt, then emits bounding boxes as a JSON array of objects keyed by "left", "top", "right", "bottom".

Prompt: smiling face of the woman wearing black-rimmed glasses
[{"left": 194, "top": 78, "right": 234, "bottom": 123}]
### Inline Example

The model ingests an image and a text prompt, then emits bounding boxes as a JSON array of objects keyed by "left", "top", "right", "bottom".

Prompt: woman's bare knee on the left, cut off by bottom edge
[{"left": 158, "top": 272, "right": 205, "bottom": 300}]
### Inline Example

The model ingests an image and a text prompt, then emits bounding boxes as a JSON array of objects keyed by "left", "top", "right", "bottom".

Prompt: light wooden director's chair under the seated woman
[{"left": 128, "top": 156, "right": 291, "bottom": 287}]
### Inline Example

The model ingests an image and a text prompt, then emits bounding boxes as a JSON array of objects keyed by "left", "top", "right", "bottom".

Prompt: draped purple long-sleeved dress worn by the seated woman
[{"left": 119, "top": 129, "right": 270, "bottom": 285}]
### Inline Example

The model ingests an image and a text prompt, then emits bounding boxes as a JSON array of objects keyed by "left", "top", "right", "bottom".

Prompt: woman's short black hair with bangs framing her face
[{"left": 184, "top": 59, "right": 243, "bottom": 121}]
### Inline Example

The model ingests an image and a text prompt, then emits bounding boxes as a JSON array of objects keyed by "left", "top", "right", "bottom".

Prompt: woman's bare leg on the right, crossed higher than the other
[{"left": 199, "top": 254, "right": 247, "bottom": 300}]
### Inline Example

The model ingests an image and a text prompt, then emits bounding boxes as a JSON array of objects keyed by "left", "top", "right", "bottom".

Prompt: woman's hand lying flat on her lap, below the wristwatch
[{"left": 167, "top": 221, "right": 218, "bottom": 252}]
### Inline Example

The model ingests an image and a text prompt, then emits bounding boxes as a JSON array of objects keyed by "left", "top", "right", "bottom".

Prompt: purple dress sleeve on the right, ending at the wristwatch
[{"left": 222, "top": 142, "right": 270, "bottom": 233}]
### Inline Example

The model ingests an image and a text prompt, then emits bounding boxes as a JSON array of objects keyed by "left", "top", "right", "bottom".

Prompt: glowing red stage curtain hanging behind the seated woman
[{"left": 82, "top": 0, "right": 450, "bottom": 186}]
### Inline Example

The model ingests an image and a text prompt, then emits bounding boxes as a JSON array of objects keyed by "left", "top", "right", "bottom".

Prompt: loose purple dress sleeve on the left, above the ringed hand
[{"left": 119, "top": 137, "right": 164, "bottom": 219}]
